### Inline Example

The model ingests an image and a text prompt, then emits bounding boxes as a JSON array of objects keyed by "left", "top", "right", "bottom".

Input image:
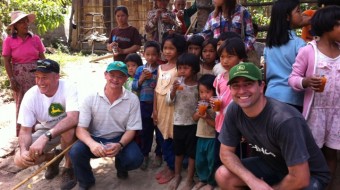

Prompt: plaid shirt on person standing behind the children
[{"left": 201, "top": 4, "right": 255, "bottom": 51}]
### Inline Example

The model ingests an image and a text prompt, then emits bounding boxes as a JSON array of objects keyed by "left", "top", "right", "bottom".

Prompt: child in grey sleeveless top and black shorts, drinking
[{"left": 167, "top": 53, "right": 200, "bottom": 190}]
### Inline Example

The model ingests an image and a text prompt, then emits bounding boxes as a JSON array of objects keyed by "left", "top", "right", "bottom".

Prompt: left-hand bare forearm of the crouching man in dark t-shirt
[{"left": 220, "top": 144, "right": 272, "bottom": 189}]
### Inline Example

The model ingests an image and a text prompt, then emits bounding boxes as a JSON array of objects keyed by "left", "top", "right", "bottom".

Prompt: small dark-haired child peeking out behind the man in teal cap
[{"left": 124, "top": 53, "right": 143, "bottom": 94}]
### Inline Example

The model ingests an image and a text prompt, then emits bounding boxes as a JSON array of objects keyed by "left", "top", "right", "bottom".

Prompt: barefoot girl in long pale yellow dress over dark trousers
[{"left": 152, "top": 33, "right": 186, "bottom": 184}]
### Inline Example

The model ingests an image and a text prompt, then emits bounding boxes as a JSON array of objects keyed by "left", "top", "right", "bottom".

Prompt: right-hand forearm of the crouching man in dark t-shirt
[{"left": 273, "top": 162, "right": 310, "bottom": 190}]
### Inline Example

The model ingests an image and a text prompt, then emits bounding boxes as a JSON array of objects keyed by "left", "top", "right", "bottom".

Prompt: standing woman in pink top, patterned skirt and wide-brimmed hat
[{"left": 2, "top": 11, "right": 45, "bottom": 135}]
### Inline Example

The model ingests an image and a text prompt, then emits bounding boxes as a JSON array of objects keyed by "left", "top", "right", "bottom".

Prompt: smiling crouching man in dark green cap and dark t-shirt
[{"left": 215, "top": 63, "right": 330, "bottom": 190}]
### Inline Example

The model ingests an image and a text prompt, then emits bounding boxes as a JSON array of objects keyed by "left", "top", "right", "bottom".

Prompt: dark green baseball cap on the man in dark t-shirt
[{"left": 228, "top": 62, "right": 262, "bottom": 85}]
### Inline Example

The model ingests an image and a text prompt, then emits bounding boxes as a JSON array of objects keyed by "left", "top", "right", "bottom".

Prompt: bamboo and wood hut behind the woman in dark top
[{"left": 69, "top": 0, "right": 195, "bottom": 51}]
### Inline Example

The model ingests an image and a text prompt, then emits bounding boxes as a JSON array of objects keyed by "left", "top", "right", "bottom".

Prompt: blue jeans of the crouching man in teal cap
[{"left": 69, "top": 136, "right": 144, "bottom": 187}]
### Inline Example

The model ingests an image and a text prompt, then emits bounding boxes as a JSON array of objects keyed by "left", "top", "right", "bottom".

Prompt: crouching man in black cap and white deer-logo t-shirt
[{"left": 14, "top": 59, "right": 79, "bottom": 189}]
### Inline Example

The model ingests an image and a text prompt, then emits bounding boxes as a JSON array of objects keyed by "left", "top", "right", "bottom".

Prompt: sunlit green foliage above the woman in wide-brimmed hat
[{"left": 0, "top": 0, "right": 72, "bottom": 35}]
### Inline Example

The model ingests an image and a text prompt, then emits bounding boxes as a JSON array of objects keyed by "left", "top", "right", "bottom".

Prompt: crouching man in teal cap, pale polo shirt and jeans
[{"left": 69, "top": 61, "right": 144, "bottom": 189}]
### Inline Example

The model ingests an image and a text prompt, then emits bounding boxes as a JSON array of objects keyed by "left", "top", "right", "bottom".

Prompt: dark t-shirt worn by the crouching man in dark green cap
[{"left": 219, "top": 98, "right": 329, "bottom": 183}]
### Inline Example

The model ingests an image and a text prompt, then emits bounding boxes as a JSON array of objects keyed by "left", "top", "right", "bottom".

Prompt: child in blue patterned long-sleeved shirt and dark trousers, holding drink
[{"left": 132, "top": 41, "right": 163, "bottom": 170}]
